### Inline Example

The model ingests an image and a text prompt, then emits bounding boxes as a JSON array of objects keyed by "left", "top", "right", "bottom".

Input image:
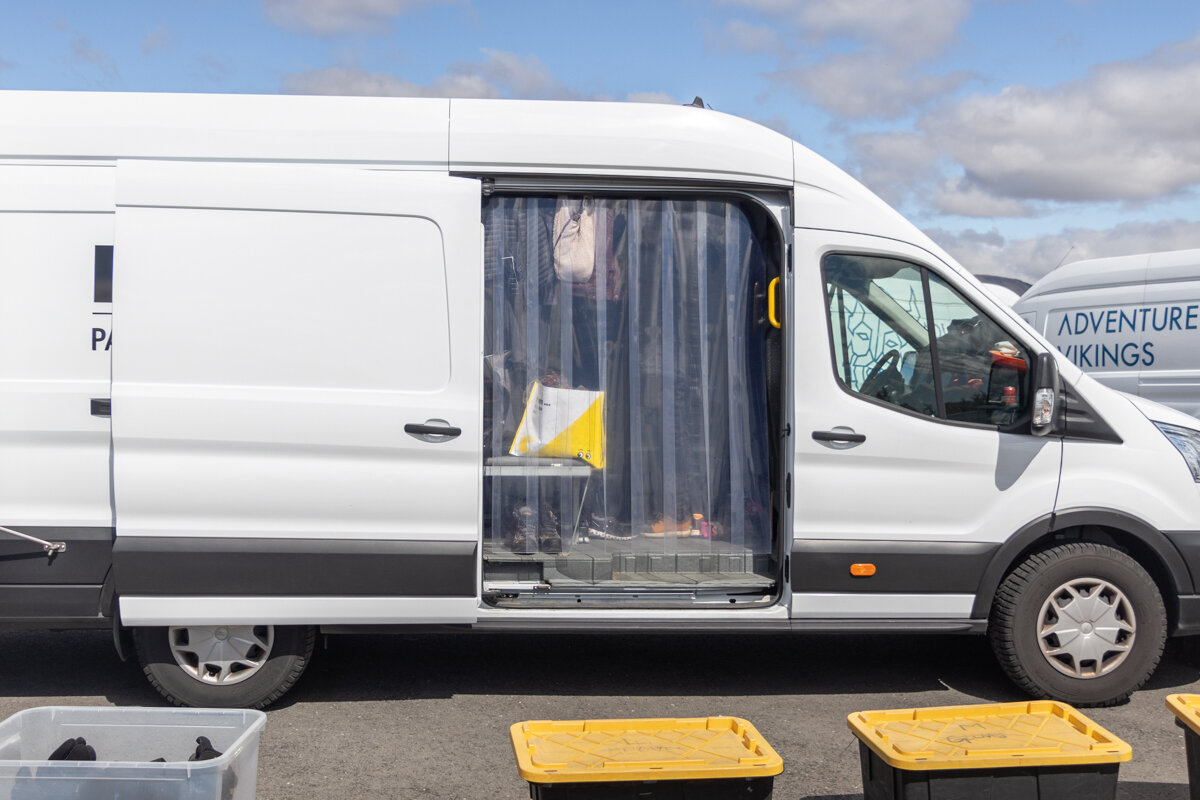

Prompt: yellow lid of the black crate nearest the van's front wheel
[{"left": 847, "top": 700, "right": 1133, "bottom": 770}]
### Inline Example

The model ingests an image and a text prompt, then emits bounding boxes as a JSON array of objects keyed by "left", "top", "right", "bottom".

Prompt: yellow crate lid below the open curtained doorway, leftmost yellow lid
[{"left": 509, "top": 717, "right": 784, "bottom": 783}]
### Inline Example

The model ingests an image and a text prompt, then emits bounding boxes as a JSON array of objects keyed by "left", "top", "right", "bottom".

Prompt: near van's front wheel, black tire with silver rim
[{"left": 988, "top": 542, "right": 1166, "bottom": 706}]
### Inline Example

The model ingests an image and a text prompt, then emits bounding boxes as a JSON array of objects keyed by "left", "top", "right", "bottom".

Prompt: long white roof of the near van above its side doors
[{"left": 0, "top": 91, "right": 801, "bottom": 186}]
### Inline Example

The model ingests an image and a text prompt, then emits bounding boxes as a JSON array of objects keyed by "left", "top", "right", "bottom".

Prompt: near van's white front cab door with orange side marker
[{"left": 791, "top": 228, "right": 1062, "bottom": 621}]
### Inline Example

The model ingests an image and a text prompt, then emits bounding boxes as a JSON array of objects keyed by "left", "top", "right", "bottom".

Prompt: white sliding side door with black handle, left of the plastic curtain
[{"left": 112, "top": 162, "right": 481, "bottom": 625}]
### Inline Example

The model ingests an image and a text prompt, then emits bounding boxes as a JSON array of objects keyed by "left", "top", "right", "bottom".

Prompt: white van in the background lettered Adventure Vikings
[{"left": 1013, "top": 249, "right": 1200, "bottom": 425}]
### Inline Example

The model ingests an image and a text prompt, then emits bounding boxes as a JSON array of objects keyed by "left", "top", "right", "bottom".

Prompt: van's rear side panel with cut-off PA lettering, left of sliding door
[{"left": 0, "top": 163, "right": 115, "bottom": 620}]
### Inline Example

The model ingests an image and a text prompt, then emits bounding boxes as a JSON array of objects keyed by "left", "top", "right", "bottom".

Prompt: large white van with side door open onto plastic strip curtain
[{"left": 7, "top": 92, "right": 1200, "bottom": 706}]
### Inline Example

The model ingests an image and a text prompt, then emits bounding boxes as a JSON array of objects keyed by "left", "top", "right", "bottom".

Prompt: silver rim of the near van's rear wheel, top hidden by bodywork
[{"left": 167, "top": 625, "right": 275, "bottom": 686}]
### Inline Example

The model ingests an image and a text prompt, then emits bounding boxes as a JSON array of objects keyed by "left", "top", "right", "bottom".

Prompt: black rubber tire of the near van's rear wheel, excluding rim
[{"left": 133, "top": 625, "right": 317, "bottom": 709}]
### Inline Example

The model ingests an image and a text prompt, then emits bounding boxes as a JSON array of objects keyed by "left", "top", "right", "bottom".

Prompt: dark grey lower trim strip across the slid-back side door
[{"left": 113, "top": 536, "right": 476, "bottom": 597}]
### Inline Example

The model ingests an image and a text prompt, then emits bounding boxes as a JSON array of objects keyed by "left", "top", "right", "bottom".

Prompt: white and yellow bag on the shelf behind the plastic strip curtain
[{"left": 509, "top": 383, "right": 605, "bottom": 469}]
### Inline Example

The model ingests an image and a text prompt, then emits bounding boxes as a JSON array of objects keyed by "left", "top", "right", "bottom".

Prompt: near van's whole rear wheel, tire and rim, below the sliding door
[{"left": 133, "top": 625, "right": 317, "bottom": 709}]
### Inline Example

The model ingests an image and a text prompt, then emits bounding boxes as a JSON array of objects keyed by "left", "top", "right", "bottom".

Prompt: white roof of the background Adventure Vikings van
[{"left": 1021, "top": 249, "right": 1200, "bottom": 301}]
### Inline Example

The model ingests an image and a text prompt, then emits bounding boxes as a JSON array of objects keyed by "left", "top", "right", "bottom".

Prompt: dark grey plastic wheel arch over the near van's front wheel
[{"left": 971, "top": 509, "right": 1194, "bottom": 631}]
